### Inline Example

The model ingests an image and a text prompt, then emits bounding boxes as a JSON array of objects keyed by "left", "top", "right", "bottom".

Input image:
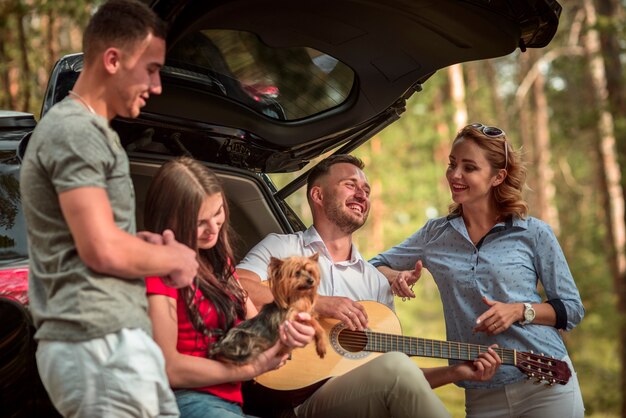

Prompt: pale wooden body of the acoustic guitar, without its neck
[{"left": 255, "top": 301, "right": 402, "bottom": 390}]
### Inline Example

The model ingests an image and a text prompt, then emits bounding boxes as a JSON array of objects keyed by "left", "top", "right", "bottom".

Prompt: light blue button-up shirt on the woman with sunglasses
[{"left": 370, "top": 216, "right": 585, "bottom": 388}]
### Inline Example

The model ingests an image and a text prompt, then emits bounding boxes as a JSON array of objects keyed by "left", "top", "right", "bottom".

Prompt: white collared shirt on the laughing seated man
[{"left": 237, "top": 226, "right": 394, "bottom": 309}]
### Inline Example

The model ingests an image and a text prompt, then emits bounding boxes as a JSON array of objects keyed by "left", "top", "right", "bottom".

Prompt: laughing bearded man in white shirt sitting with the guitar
[{"left": 237, "top": 155, "right": 501, "bottom": 418}]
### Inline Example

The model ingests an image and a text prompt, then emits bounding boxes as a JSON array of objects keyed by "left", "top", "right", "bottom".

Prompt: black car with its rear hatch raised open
[{"left": 0, "top": 0, "right": 561, "bottom": 416}]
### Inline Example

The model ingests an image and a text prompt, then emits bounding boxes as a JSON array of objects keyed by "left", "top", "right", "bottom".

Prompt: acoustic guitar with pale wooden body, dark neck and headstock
[{"left": 255, "top": 301, "right": 571, "bottom": 393}]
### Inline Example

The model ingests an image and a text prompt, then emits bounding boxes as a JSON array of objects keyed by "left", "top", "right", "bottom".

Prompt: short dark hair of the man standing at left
[{"left": 83, "top": 0, "right": 167, "bottom": 62}]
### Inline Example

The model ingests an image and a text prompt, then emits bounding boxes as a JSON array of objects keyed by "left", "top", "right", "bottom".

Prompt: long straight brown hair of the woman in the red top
[{"left": 144, "top": 157, "right": 247, "bottom": 342}]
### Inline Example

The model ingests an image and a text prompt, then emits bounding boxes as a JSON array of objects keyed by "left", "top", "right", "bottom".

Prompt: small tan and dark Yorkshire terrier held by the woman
[{"left": 210, "top": 253, "right": 326, "bottom": 364}]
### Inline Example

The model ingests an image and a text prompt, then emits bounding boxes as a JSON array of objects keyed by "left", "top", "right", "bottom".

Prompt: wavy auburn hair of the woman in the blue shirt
[{"left": 449, "top": 125, "right": 528, "bottom": 221}]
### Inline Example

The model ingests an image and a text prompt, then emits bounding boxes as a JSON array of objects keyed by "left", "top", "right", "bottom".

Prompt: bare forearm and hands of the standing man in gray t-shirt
[{"left": 59, "top": 187, "right": 198, "bottom": 287}]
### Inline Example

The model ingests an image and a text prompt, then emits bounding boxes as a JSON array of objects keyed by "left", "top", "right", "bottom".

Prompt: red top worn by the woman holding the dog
[{"left": 146, "top": 277, "right": 243, "bottom": 404}]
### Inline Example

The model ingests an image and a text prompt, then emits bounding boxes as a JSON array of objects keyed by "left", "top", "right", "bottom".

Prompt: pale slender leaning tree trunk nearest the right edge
[{"left": 583, "top": 0, "right": 626, "bottom": 416}]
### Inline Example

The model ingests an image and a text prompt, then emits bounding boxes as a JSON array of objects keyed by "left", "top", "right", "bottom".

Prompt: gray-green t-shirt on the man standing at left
[{"left": 20, "top": 98, "right": 151, "bottom": 341}]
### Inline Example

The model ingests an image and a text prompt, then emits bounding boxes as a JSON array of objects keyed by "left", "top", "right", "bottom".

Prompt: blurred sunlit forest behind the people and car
[{"left": 0, "top": 0, "right": 626, "bottom": 417}]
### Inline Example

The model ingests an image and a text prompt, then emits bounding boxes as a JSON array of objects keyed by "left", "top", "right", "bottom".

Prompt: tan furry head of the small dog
[{"left": 268, "top": 253, "right": 320, "bottom": 309}]
